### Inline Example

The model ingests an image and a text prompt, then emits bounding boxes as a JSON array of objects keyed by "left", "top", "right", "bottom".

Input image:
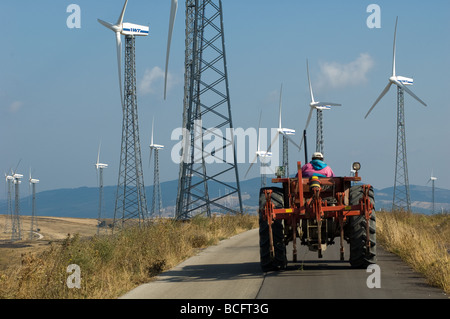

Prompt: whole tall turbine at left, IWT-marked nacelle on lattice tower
[{"left": 98, "top": 0, "right": 149, "bottom": 228}]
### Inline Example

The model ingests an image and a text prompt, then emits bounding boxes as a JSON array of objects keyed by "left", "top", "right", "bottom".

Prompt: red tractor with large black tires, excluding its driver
[{"left": 259, "top": 162, "right": 376, "bottom": 271}]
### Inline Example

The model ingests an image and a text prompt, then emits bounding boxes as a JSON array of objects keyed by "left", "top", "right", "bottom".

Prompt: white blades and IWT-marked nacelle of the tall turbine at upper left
[{"left": 97, "top": 0, "right": 150, "bottom": 107}]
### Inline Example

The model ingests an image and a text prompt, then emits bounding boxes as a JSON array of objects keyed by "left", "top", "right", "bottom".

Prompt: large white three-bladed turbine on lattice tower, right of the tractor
[{"left": 365, "top": 17, "right": 427, "bottom": 211}]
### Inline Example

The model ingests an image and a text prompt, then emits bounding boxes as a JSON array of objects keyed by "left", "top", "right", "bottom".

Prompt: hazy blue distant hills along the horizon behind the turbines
[{"left": 0, "top": 178, "right": 450, "bottom": 218}]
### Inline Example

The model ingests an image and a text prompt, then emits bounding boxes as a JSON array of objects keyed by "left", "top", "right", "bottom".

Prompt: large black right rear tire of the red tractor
[{"left": 347, "top": 185, "right": 377, "bottom": 268}]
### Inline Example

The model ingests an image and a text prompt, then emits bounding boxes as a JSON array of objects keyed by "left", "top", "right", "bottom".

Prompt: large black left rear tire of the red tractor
[{"left": 259, "top": 187, "right": 287, "bottom": 272}]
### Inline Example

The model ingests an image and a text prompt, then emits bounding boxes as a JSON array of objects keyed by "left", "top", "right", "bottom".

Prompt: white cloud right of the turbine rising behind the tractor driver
[{"left": 318, "top": 53, "right": 374, "bottom": 88}]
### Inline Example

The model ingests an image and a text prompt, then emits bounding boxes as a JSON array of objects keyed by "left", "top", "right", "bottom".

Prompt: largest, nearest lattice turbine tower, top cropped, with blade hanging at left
[{"left": 164, "top": 0, "right": 243, "bottom": 219}]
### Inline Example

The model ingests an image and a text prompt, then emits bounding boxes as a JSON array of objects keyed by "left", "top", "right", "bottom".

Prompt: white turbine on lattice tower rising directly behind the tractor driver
[{"left": 300, "top": 60, "right": 341, "bottom": 154}]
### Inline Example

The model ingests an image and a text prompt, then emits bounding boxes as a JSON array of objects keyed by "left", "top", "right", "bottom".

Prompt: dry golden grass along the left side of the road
[{"left": 0, "top": 215, "right": 258, "bottom": 299}]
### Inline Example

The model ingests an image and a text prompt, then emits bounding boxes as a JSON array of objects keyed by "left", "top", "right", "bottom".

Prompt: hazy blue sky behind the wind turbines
[{"left": 0, "top": 0, "right": 450, "bottom": 197}]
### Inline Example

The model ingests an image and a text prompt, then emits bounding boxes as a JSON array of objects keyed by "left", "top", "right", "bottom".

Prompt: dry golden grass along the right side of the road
[{"left": 377, "top": 211, "right": 450, "bottom": 293}]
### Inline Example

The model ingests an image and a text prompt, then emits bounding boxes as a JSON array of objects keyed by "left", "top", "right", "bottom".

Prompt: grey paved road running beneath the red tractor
[{"left": 122, "top": 229, "right": 448, "bottom": 299}]
